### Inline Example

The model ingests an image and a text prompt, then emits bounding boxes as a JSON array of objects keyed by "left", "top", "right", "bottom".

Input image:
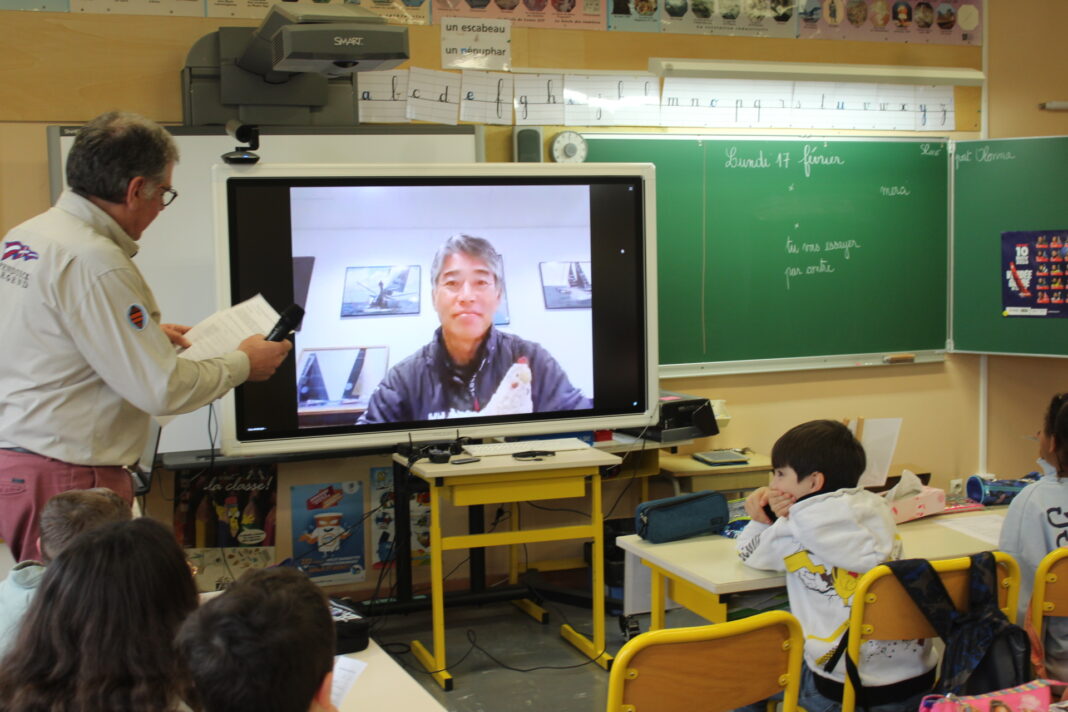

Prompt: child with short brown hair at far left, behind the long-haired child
[{"left": 0, "top": 487, "right": 132, "bottom": 656}]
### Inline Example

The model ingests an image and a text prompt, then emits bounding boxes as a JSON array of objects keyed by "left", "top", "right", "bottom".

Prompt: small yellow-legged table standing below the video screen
[{"left": 394, "top": 448, "right": 621, "bottom": 690}]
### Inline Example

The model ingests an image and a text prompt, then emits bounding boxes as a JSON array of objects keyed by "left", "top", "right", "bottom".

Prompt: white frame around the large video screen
[{"left": 213, "top": 163, "right": 659, "bottom": 456}]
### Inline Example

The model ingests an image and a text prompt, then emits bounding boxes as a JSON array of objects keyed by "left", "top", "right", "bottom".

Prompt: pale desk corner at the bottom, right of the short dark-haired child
[{"left": 337, "top": 640, "right": 445, "bottom": 712}]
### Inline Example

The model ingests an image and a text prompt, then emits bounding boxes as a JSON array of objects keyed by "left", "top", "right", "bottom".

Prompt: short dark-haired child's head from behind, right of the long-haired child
[{"left": 177, "top": 568, "right": 337, "bottom": 712}]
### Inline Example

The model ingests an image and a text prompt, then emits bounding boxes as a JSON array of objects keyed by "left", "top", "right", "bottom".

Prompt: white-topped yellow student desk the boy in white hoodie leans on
[{"left": 615, "top": 507, "right": 1007, "bottom": 630}]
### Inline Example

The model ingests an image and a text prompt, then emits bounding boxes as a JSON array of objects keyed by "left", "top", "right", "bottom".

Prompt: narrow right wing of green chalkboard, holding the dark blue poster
[{"left": 953, "top": 137, "right": 1068, "bottom": 355}]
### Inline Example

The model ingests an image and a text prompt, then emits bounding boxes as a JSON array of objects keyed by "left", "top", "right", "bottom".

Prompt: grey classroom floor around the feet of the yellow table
[{"left": 372, "top": 601, "right": 706, "bottom": 712}]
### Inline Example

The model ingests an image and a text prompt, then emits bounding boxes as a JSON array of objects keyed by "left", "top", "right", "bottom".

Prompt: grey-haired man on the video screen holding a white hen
[{"left": 359, "top": 235, "right": 592, "bottom": 424}]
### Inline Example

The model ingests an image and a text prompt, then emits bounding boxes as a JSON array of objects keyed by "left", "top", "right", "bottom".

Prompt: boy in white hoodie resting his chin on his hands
[{"left": 738, "top": 421, "right": 936, "bottom": 712}]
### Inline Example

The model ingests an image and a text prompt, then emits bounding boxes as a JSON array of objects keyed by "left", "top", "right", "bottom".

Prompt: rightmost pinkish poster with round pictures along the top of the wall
[{"left": 798, "top": 0, "right": 983, "bottom": 45}]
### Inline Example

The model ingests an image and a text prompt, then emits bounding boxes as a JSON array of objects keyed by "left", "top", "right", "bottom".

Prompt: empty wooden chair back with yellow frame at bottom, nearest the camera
[{"left": 608, "top": 611, "right": 804, "bottom": 712}]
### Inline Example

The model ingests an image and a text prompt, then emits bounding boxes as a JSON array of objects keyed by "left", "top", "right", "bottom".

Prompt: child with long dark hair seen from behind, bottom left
[{"left": 0, "top": 519, "right": 197, "bottom": 712}]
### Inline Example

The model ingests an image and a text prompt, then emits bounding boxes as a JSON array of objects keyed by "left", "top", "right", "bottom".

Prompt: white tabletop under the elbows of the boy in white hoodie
[{"left": 615, "top": 507, "right": 1007, "bottom": 595}]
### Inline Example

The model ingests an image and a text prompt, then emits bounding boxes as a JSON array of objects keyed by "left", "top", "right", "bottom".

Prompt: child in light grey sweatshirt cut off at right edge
[{"left": 1000, "top": 393, "right": 1068, "bottom": 680}]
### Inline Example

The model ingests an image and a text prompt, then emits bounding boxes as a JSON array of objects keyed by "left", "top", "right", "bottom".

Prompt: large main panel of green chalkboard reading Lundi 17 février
[{"left": 586, "top": 135, "right": 948, "bottom": 365}]
